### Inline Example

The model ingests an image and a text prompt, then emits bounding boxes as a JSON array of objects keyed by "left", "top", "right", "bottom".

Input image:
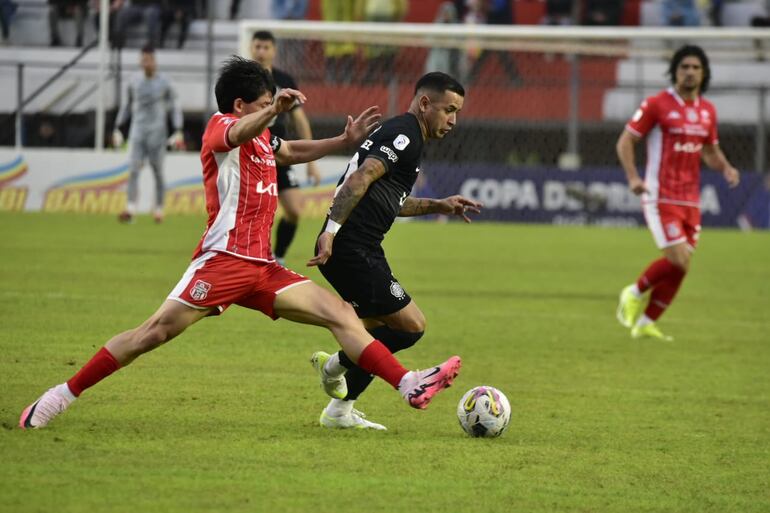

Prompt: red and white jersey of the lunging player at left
[{"left": 193, "top": 112, "right": 281, "bottom": 262}]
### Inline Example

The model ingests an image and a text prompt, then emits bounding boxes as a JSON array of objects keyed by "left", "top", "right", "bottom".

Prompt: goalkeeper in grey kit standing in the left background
[{"left": 112, "top": 47, "right": 184, "bottom": 223}]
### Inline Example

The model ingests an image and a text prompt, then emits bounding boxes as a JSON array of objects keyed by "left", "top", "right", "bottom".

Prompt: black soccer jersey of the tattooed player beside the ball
[{"left": 334, "top": 113, "right": 424, "bottom": 246}]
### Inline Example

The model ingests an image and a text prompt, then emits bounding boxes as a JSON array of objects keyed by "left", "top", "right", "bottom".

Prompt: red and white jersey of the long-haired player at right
[{"left": 626, "top": 88, "right": 719, "bottom": 206}]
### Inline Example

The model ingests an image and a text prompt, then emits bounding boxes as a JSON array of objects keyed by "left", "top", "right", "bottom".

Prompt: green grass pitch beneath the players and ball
[{"left": 0, "top": 210, "right": 770, "bottom": 513}]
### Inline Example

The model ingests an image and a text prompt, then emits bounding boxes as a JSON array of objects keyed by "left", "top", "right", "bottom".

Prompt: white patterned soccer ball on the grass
[{"left": 457, "top": 385, "right": 511, "bottom": 438}]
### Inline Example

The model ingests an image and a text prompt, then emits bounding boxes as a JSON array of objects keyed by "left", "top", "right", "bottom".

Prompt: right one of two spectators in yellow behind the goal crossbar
[{"left": 364, "top": 0, "right": 409, "bottom": 83}]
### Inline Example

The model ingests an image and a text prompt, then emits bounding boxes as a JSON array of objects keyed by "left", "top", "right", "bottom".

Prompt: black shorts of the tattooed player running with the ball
[{"left": 319, "top": 243, "right": 412, "bottom": 319}]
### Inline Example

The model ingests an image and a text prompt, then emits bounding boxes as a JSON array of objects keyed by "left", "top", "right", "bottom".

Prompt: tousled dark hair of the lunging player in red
[{"left": 214, "top": 55, "right": 275, "bottom": 114}]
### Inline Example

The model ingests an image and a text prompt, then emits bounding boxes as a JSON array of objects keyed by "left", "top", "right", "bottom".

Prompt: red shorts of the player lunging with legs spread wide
[{"left": 168, "top": 251, "right": 310, "bottom": 319}]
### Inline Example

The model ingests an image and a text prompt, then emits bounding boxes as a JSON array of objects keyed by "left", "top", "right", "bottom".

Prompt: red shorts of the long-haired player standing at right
[{"left": 642, "top": 203, "right": 700, "bottom": 249}]
